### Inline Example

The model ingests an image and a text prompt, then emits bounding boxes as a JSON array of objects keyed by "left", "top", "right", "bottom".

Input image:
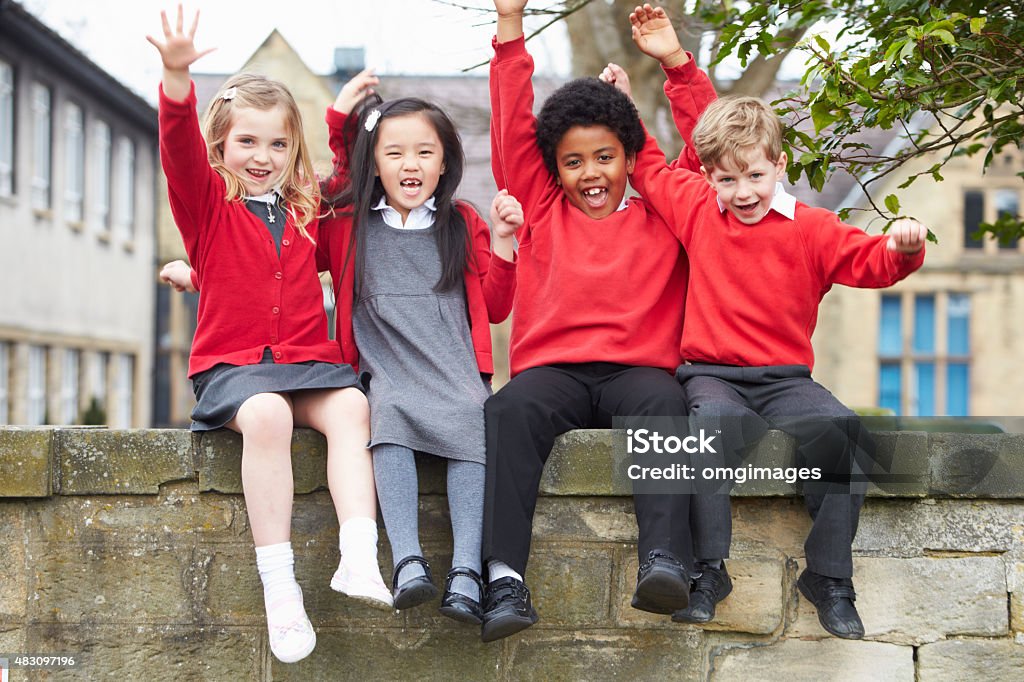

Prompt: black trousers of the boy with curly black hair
[{"left": 483, "top": 363, "right": 693, "bottom": 574}]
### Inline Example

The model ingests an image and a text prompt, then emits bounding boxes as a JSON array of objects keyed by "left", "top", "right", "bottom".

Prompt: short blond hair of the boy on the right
[{"left": 693, "top": 97, "right": 782, "bottom": 171}]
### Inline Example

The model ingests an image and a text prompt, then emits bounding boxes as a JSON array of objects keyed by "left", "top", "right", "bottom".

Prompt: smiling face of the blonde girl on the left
[{"left": 224, "top": 106, "right": 291, "bottom": 196}]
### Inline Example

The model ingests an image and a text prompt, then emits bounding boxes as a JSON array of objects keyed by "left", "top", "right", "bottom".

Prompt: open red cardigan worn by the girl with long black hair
[{"left": 317, "top": 108, "right": 516, "bottom": 375}]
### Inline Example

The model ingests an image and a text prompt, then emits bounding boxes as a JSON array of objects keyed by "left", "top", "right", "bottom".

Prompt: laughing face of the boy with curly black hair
[{"left": 555, "top": 126, "right": 636, "bottom": 219}]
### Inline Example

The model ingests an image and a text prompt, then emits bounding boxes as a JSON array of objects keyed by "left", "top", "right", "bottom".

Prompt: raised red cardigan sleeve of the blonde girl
[{"left": 159, "top": 82, "right": 224, "bottom": 269}]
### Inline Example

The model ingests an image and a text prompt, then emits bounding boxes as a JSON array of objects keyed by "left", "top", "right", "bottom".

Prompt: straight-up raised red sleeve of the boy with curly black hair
[{"left": 490, "top": 37, "right": 559, "bottom": 228}]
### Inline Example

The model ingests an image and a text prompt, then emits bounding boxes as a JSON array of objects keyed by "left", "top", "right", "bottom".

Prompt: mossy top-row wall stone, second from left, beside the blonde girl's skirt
[{"left": 53, "top": 429, "right": 196, "bottom": 495}]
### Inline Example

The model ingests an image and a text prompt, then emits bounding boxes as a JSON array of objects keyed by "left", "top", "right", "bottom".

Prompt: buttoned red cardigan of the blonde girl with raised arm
[{"left": 160, "top": 84, "right": 341, "bottom": 377}]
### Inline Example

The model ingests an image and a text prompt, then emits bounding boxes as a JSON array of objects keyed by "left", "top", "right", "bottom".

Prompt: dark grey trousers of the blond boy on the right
[{"left": 676, "top": 365, "right": 876, "bottom": 578}]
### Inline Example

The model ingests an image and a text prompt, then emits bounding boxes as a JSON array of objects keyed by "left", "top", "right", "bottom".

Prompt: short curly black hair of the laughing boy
[{"left": 537, "top": 78, "right": 645, "bottom": 176}]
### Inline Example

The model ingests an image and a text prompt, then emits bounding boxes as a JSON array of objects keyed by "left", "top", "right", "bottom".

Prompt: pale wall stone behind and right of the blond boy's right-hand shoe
[{"left": 786, "top": 556, "right": 1009, "bottom": 644}]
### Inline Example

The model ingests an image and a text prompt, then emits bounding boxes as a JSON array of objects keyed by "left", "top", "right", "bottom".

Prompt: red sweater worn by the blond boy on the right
[{"left": 630, "top": 119, "right": 925, "bottom": 369}]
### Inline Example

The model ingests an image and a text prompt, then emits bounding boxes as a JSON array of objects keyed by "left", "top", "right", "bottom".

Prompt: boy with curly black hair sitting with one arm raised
[{"left": 481, "top": 0, "right": 715, "bottom": 641}]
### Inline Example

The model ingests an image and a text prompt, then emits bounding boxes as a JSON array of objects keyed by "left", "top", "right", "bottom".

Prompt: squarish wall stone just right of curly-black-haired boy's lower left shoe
[{"left": 525, "top": 543, "right": 613, "bottom": 626}]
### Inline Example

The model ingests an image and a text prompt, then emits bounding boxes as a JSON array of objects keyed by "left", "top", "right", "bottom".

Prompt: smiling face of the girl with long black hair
[{"left": 374, "top": 113, "right": 444, "bottom": 222}]
